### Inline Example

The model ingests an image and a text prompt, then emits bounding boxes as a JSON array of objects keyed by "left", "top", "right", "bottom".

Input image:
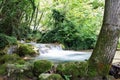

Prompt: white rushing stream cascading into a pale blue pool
[{"left": 28, "top": 43, "right": 91, "bottom": 63}]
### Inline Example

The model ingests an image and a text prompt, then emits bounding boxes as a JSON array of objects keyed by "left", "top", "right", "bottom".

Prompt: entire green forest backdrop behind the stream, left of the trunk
[{"left": 0, "top": 0, "right": 104, "bottom": 50}]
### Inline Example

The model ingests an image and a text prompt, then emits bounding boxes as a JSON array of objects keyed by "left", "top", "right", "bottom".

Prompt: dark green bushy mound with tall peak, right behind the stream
[{"left": 38, "top": 10, "right": 96, "bottom": 50}]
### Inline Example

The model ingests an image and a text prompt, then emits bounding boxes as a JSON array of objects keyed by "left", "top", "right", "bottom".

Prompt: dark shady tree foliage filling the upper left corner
[{"left": 0, "top": 0, "right": 37, "bottom": 39}]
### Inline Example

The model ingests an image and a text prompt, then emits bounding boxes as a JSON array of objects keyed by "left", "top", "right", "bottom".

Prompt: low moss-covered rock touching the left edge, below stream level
[{"left": 0, "top": 54, "right": 21, "bottom": 64}]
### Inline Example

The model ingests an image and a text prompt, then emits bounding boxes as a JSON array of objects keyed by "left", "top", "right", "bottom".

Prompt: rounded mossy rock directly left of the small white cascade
[{"left": 17, "top": 44, "right": 37, "bottom": 57}]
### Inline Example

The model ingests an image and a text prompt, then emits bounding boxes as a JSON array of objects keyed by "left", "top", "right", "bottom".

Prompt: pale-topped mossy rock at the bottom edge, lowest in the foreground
[{"left": 39, "top": 74, "right": 64, "bottom": 80}]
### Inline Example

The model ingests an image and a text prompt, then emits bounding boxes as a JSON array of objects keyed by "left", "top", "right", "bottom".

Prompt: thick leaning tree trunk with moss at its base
[{"left": 88, "top": 0, "right": 120, "bottom": 76}]
